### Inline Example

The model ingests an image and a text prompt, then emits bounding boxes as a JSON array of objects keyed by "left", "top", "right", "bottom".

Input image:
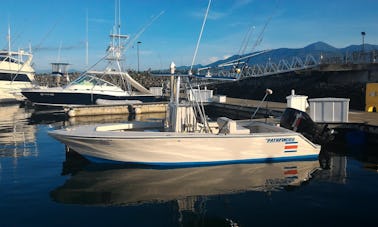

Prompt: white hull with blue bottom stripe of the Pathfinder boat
[{"left": 50, "top": 126, "right": 320, "bottom": 165}]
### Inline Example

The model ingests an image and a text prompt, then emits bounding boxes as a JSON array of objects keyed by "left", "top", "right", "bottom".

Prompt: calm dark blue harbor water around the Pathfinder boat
[{"left": 0, "top": 105, "right": 378, "bottom": 226}]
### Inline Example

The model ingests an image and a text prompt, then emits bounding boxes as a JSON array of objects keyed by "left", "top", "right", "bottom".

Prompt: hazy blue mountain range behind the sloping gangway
[{"left": 177, "top": 41, "right": 378, "bottom": 71}]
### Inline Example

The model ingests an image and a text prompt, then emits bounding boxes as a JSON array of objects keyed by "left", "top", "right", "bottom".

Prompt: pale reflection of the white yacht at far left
[{"left": 0, "top": 105, "right": 37, "bottom": 157}]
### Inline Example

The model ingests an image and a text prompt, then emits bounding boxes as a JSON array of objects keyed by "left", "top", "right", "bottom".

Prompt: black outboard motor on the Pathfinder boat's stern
[{"left": 280, "top": 108, "right": 334, "bottom": 145}]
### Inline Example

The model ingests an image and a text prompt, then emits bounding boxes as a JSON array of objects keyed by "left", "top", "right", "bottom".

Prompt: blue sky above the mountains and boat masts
[{"left": 0, "top": 0, "right": 378, "bottom": 71}]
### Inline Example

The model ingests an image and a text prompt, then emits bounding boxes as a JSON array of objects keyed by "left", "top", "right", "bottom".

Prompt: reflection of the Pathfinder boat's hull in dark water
[{"left": 50, "top": 161, "right": 319, "bottom": 205}]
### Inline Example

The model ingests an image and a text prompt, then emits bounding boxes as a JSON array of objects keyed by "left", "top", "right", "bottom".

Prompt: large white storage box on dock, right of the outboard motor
[{"left": 308, "top": 98, "right": 349, "bottom": 122}]
